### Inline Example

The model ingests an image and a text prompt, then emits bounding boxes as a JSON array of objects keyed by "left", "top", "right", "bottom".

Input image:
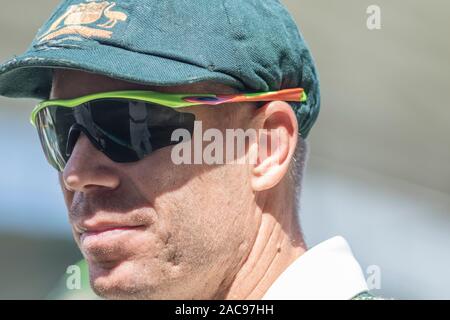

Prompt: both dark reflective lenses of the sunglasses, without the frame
[{"left": 36, "top": 99, "right": 195, "bottom": 170}]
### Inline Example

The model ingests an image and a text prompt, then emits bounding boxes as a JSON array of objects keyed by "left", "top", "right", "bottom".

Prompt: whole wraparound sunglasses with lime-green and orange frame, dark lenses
[{"left": 31, "top": 88, "right": 307, "bottom": 171}]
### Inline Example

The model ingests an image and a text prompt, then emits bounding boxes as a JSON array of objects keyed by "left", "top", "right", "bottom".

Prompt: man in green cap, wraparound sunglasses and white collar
[{"left": 0, "top": 0, "right": 367, "bottom": 299}]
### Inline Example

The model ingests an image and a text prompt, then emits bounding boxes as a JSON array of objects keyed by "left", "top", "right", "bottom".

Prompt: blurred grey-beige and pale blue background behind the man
[{"left": 0, "top": 0, "right": 450, "bottom": 299}]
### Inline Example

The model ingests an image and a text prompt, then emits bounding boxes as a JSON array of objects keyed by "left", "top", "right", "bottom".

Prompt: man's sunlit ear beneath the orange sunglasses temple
[{"left": 250, "top": 101, "right": 298, "bottom": 191}]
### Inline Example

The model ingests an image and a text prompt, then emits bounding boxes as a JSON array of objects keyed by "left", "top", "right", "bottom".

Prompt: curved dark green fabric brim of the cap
[{"left": 0, "top": 44, "right": 244, "bottom": 99}]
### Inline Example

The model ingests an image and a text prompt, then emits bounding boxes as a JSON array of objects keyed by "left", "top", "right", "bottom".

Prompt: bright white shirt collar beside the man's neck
[{"left": 263, "top": 236, "right": 368, "bottom": 300}]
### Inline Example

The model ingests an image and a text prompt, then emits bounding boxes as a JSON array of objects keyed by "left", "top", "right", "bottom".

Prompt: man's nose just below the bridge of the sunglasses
[{"left": 63, "top": 133, "right": 120, "bottom": 192}]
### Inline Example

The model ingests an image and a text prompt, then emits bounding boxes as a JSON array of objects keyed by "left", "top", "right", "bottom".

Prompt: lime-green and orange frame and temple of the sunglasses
[{"left": 30, "top": 88, "right": 307, "bottom": 126}]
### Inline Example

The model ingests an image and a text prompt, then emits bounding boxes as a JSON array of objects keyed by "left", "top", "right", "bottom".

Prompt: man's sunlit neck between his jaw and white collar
[{"left": 225, "top": 182, "right": 306, "bottom": 300}]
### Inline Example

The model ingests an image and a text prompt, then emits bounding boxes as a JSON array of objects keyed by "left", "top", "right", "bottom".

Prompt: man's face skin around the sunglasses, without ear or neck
[{"left": 52, "top": 71, "right": 259, "bottom": 299}]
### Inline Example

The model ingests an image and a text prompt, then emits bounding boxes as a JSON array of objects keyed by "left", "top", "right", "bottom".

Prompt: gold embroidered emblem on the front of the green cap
[{"left": 39, "top": 0, "right": 128, "bottom": 42}]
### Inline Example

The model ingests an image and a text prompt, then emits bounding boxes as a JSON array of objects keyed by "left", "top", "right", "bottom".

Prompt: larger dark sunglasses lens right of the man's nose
[{"left": 84, "top": 99, "right": 195, "bottom": 162}]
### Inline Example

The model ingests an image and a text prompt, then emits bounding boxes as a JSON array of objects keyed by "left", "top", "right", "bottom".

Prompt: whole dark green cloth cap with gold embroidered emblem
[{"left": 0, "top": 0, "right": 320, "bottom": 137}]
